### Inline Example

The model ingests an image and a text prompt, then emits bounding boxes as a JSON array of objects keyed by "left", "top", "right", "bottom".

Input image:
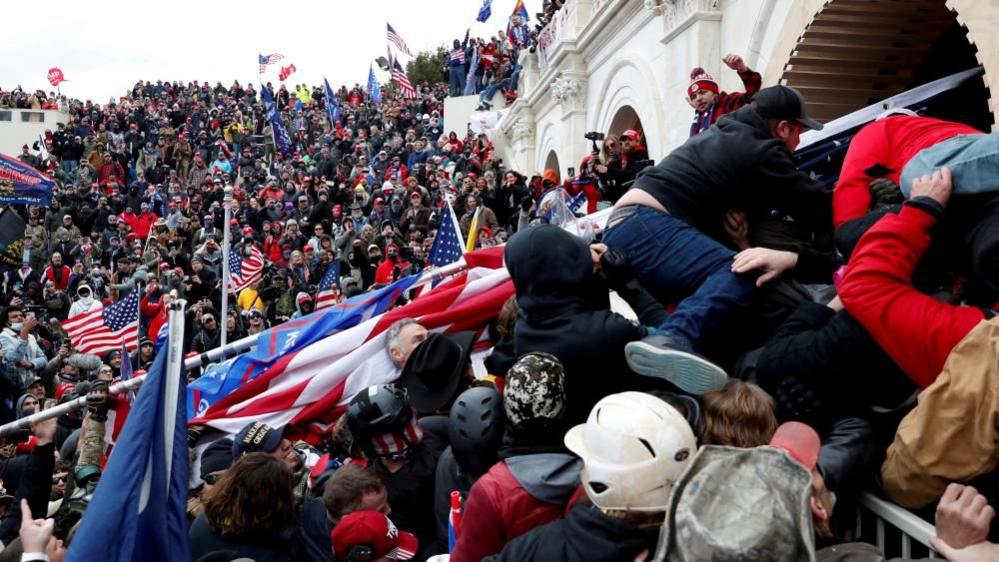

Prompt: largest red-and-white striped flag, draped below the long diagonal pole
[{"left": 190, "top": 247, "right": 514, "bottom": 441}]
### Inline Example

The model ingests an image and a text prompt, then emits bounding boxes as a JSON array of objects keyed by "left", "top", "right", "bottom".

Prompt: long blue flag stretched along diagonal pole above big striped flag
[{"left": 187, "top": 275, "right": 420, "bottom": 419}]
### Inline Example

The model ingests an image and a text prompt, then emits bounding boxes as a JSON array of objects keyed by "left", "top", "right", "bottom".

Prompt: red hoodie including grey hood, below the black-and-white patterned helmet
[{"left": 451, "top": 453, "right": 583, "bottom": 562}]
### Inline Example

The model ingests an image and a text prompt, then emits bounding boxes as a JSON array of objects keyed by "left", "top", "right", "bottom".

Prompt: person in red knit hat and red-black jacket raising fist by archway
[{"left": 687, "top": 55, "right": 763, "bottom": 137}]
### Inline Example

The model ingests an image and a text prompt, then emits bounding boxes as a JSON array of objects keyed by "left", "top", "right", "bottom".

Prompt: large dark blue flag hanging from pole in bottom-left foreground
[{"left": 65, "top": 334, "right": 191, "bottom": 562}]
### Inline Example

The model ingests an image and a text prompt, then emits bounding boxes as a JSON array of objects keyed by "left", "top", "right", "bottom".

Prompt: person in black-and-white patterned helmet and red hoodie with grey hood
[{"left": 451, "top": 353, "right": 583, "bottom": 562}]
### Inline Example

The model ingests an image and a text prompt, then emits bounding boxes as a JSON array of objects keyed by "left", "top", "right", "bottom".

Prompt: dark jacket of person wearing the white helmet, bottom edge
[{"left": 483, "top": 503, "right": 659, "bottom": 562}]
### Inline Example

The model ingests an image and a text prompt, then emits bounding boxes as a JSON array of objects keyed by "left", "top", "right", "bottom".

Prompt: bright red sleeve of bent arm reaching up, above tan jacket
[{"left": 839, "top": 199, "right": 985, "bottom": 388}]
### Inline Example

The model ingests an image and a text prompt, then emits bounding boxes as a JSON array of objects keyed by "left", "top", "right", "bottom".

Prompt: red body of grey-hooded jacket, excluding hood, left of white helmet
[{"left": 451, "top": 456, "right": 575, "bottom": 562}]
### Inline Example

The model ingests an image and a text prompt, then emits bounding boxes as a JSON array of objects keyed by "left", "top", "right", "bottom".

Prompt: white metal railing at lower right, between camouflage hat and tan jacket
[{"left": 857, "top": 492, "right": 940, "bottom": 558}]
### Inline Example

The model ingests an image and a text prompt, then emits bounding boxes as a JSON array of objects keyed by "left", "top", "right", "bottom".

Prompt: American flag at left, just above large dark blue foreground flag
[{"left": 63, "top": 289, "right": 139, "bottom": 354}]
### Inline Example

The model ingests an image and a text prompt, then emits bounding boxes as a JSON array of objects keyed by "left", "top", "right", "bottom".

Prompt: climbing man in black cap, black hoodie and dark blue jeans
[{"left": 603, "top": 86, "right": 831, "bottom": 394}]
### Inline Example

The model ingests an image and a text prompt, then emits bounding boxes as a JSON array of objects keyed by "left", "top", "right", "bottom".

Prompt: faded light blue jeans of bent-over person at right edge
[{"left": 899, "top": 132, "right": 999, "bottom": 198}]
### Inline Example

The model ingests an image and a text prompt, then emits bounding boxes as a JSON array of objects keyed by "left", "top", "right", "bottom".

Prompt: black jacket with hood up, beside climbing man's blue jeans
[{"left": 508, "top": 225, "right": 666, "bottom": 423}]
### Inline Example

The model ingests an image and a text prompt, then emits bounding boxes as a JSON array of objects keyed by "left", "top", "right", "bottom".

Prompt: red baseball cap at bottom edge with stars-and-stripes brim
[{"left": 330, "top": 510, "right": 420, "bottom": 560}]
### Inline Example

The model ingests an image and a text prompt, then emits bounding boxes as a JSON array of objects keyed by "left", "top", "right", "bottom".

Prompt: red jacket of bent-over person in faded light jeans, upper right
[{"left": 833, "top": 115, "right": 982, "bottom": 228}]
